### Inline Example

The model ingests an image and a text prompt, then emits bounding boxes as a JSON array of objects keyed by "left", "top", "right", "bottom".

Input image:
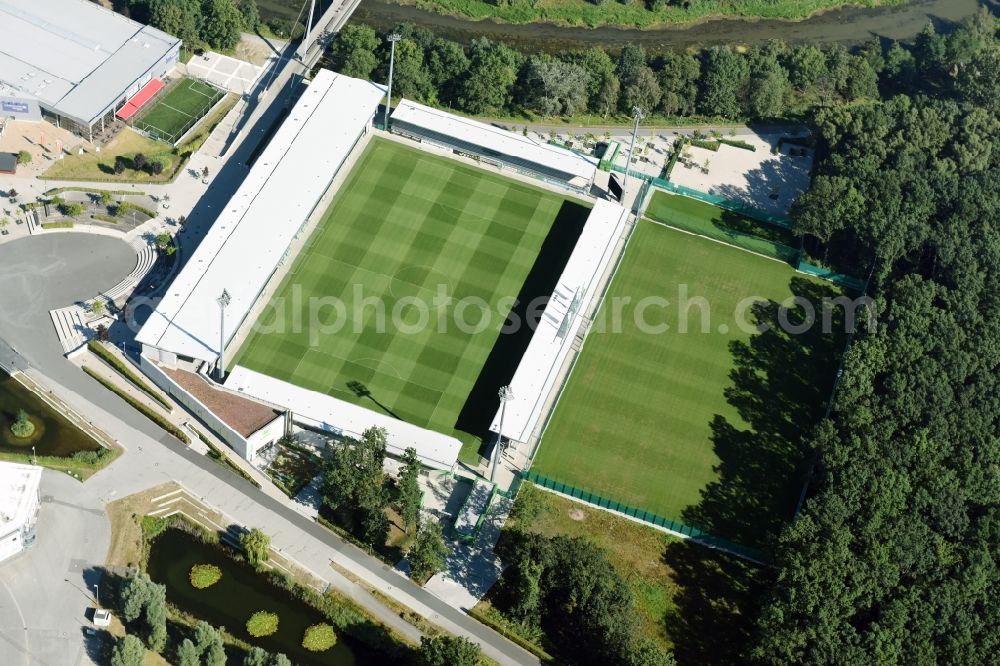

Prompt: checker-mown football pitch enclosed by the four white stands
[{"left": 237, "top": 138, "right": 590, "bottom": 461}]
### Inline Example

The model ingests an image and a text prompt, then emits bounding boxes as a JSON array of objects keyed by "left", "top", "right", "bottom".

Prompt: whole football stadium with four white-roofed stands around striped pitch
[{"left": 137, "top": 70, "right": 629, "bottom": 469}]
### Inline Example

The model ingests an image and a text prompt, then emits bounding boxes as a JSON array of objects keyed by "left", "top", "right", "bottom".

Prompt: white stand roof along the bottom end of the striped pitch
[{"left": 226, "top": 365, "right": 462, "bottom": 469}]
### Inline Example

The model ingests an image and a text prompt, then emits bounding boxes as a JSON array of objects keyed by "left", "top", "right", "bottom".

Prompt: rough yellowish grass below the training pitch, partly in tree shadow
[{"left": 476, "top": 483, "right": 766, "bottom": 664}]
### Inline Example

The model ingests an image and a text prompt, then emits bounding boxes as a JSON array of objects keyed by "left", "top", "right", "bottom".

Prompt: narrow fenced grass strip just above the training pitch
[{"left": 646, "top": 190, "right": 800, "bottom": 264}]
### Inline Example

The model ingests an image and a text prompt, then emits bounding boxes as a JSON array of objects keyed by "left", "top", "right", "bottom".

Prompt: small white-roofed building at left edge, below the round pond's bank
[{"left": 0, "top": 462, "right": 42, "bottom": 562}]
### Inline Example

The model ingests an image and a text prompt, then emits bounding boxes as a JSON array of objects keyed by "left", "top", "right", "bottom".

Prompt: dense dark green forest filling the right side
[{"left": 752, "top": 14, "right": 1000, "bottom": 664}]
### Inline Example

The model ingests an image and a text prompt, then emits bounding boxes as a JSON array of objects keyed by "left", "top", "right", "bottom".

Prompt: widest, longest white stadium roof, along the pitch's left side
[{"left": 136, "top": 70, "right": 384, "bottom": 364}]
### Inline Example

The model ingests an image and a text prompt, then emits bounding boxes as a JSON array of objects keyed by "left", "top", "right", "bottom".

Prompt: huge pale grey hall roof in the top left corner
[{"left": 0, "top": 0, "right": 180, "bottom": 124}]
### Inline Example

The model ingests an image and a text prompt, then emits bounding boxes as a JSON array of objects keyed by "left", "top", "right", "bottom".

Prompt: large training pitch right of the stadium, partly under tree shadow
[{"left": 532, "top": 220, "right": 840, "bottom": 545}]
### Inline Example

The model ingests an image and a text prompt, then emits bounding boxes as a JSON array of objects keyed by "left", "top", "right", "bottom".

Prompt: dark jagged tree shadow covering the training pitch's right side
[{"left": 682, "top": 277, "right": 845, "bottom": 547}]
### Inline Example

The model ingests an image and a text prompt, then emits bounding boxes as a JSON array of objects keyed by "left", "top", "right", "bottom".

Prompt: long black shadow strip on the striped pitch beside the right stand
[{"left": 455, "top": 201, "right": 590, "bottom": 454}]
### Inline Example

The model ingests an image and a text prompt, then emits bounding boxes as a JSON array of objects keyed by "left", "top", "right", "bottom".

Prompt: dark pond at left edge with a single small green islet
[{"left": 0, "top": 371, "right": 101, "bottom": 457}]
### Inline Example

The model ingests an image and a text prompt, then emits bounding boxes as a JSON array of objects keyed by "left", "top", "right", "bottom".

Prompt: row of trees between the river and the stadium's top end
[{"left": 331, "top": 24, "right": 884, "bottom": 119}]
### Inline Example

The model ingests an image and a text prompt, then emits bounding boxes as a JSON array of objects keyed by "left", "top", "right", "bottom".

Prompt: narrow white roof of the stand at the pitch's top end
[{"left": 392, "top": 99, "right": 597, "bottom": 181}]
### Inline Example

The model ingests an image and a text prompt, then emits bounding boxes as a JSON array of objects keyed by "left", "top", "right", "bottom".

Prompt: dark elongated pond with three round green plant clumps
[{"left": 146, "top": 529, "right": 383, "bottom": 666}]
